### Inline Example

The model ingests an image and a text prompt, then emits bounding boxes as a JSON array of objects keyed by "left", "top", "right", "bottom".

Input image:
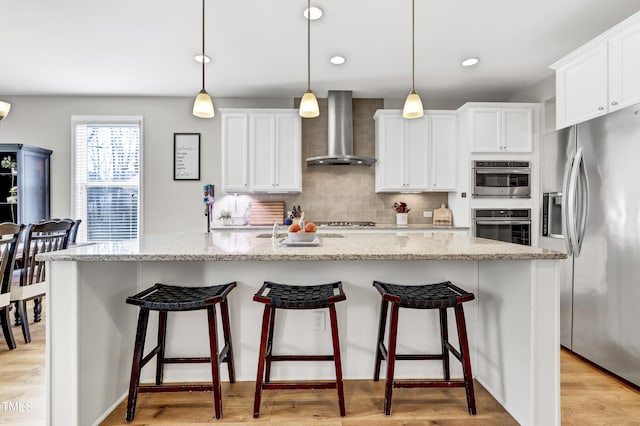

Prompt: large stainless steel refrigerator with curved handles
[{"left": 540, "top": 104, "right": 640, "bottom": 386}]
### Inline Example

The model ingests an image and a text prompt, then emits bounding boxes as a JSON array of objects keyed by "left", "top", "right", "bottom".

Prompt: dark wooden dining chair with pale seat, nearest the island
[{"left": 11, "top": 220, "right": 73, "bottom": 343}]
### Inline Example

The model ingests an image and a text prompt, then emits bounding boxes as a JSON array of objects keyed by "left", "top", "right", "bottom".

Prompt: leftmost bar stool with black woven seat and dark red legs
[{"left": 126, "top": 282, "right": 236, "bottom": 422}]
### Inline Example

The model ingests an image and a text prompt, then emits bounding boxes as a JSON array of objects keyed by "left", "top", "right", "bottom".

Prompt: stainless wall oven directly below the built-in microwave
[{"left": 473, "top": 209, "right": 531, "bottom": 246}]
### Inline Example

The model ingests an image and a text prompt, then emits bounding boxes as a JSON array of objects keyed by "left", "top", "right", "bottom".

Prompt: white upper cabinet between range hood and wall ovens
[{"left": 375, "top": 110, "right": 457, "bottom": 192}]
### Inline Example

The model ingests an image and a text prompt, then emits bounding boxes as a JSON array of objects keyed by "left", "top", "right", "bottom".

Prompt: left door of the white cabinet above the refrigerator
[{"left": 556, "top": 43, "right": 608, "bottom": 129}]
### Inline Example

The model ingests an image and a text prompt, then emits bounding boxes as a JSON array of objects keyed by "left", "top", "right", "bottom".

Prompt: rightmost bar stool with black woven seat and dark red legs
[{"left": 373, "top": 281, "right": 476, "bottom": 415}]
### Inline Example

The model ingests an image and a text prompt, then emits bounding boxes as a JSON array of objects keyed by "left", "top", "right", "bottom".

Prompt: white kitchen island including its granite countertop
[{"left": 41, "top": 231, "right": 565, "bottom": 426}]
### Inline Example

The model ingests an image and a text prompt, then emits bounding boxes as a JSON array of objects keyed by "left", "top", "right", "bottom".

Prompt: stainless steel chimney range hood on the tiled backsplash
[{"left": 307, "top": 90, "right": 376, "bottom": 166}]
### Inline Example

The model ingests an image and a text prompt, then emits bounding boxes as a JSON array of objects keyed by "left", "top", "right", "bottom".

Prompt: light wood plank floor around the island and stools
[{"left": 0, "top": 306, "right": 640, "bottom": 426}]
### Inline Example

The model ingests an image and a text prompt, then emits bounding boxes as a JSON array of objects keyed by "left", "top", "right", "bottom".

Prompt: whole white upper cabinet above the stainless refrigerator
[{"left": 551, "top": 14, "right": 640, "bottom": 129}]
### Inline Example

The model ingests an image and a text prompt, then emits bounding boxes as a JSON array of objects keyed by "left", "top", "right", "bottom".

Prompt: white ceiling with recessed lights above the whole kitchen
[{"left": 0, "top": 0, "right": 640, "bottom": 101}]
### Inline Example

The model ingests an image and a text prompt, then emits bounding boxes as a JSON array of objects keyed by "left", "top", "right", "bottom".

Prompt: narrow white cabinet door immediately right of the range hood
[{"left": 376, "top": 113, "right": 406, "bottom": 192}]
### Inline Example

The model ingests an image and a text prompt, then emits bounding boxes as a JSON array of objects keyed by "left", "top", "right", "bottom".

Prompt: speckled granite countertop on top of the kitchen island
[{"left": 37, "top": 231, "right": 566, "bottom": 262}]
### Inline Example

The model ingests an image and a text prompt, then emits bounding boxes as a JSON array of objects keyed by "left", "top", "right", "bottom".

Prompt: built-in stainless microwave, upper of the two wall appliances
[{"left": 472, "top": 160, "right": 531, "bottom": 198}]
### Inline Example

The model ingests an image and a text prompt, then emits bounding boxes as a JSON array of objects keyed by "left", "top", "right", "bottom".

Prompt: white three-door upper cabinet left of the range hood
[{"left": 221, "top": 109, "right": 302, "bottom": 192}]
